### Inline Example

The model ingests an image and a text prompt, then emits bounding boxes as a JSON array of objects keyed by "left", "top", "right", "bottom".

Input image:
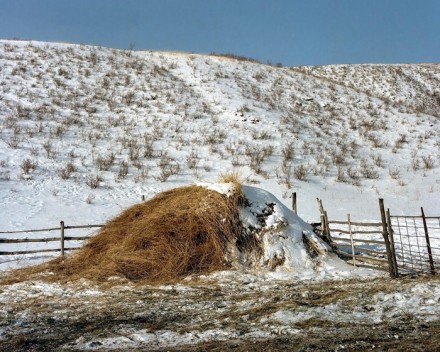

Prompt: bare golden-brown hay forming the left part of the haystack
[{"left": 50, "top": 186, "right": 244, "bottom": 282}]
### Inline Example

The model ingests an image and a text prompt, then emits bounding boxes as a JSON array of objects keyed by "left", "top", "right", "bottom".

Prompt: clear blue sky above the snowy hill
[{"left": 0, "top": 0, "right": 440, "bottom": 66}]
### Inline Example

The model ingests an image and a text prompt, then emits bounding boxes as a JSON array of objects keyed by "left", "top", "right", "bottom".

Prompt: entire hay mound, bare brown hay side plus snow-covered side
[{"left": 17, "top": 181, "right": 360, "bottom": 282}]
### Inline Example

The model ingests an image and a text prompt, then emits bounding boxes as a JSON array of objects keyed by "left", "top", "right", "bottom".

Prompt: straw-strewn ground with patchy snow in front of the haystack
[{"left": 0, "top": 276, "right": 440, "bottom": 352}]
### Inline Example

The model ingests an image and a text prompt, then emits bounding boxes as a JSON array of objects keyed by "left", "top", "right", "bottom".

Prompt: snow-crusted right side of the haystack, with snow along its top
[{"left": 198, "top": 184, "right": 356, "bottom": 278}]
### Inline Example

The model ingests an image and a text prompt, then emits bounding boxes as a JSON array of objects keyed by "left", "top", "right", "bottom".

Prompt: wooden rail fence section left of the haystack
[{"left": 0, "top": 221, "right": 104, "bottom": 256}]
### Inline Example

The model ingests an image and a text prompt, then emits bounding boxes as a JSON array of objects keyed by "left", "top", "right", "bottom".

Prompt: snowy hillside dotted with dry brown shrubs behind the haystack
[{"left": 0, "top": 41, "right": 440, "bottom": 234}]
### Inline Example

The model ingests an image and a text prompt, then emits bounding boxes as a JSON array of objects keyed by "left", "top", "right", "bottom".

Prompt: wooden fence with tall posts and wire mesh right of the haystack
[{"left": 318, "top": 199, "right": 440, "bottom": 278}]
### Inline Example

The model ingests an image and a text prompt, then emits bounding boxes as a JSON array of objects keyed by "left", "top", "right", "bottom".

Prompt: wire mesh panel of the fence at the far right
[{"left": 391, "top": 216, "right": 440, "bottom": 274}]
